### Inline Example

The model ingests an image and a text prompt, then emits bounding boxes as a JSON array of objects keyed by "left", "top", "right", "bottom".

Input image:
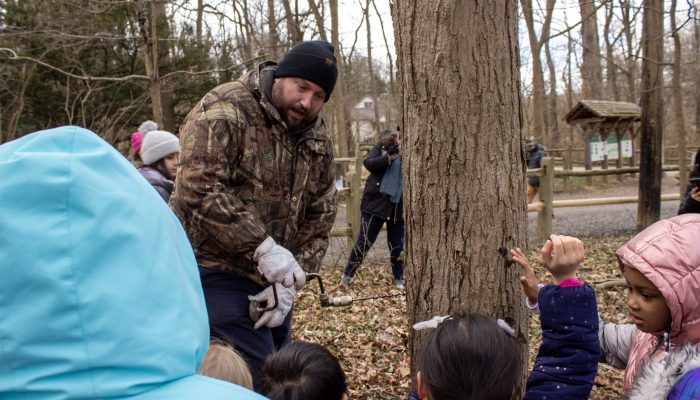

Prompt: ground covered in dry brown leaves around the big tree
[{"left": 293, "top": 236, "right": 629, "bottom": 399}]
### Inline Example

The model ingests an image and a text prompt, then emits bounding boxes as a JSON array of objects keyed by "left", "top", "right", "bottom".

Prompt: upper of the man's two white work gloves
[{"left": 253, "top": 236, "right": 306, "bottom": 290}]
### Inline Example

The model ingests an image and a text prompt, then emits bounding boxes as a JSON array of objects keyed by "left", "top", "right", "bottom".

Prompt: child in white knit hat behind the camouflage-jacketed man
[{"left": 138, "top": 130, "right": 180, "bottom": 203}]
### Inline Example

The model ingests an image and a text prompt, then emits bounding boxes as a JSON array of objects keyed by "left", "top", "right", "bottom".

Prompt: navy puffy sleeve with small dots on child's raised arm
[{"left": 525, "top": 285, "right": 600, "bottom": 399}]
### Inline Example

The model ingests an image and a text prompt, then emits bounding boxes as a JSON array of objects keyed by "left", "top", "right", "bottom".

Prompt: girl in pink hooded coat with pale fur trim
[{"left": 600, "top": 214, "right": 700, "bottom": 400}]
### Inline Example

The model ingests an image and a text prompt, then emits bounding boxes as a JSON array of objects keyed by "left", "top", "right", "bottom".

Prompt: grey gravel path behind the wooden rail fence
[{"left": 323, "top": 173, "right": 679, "bottom": 274}]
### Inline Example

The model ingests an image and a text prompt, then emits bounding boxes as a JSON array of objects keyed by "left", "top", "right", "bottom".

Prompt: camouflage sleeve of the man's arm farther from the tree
[{"left": 171, "top": 102, "right": 267, "bottom": 263}]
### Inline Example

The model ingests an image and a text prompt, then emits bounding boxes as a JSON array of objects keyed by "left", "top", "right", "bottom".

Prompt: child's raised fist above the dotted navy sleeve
[{"left": 541, "top": 235, "right": 584, "bottom": 284}]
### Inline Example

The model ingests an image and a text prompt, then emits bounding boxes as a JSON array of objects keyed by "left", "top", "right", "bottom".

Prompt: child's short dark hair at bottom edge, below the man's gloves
[{"left": 260, "top": 341, "right": 347, "bottom": 400}]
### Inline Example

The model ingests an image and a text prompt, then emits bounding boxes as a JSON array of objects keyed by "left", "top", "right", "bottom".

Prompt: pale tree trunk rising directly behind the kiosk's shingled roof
[{"left": 579, "top": 0, "right": 602, "bottom": 100}]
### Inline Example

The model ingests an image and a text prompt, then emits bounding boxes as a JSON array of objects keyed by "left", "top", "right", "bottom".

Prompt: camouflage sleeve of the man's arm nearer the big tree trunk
[{"left": 295, "top": 143, "right": 338, "bottom": 272}]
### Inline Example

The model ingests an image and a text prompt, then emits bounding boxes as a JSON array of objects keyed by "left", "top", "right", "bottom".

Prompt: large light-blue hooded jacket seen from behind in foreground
[{"left": 0, "top": 127, "right": 263, "bottom": 399}]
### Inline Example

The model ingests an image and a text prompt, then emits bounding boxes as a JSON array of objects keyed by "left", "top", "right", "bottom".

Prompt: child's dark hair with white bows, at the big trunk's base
[{"left": 418, "top": 313, "right": 520, "bottom": 400}]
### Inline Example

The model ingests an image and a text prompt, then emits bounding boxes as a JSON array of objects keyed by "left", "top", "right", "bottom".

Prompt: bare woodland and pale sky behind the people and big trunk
[{"left": 0, "top": 0, "right": 700, "bottom": 156}]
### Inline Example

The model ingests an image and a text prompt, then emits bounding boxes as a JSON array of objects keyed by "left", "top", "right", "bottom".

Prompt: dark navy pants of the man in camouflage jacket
[{"left": 199, "top": 267, "right": 292, "bottom": 388}]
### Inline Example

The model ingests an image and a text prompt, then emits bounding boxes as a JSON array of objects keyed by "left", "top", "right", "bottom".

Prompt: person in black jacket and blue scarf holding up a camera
[{"left": 340, "top": 129, "right": 404, "bottom": 290}]
